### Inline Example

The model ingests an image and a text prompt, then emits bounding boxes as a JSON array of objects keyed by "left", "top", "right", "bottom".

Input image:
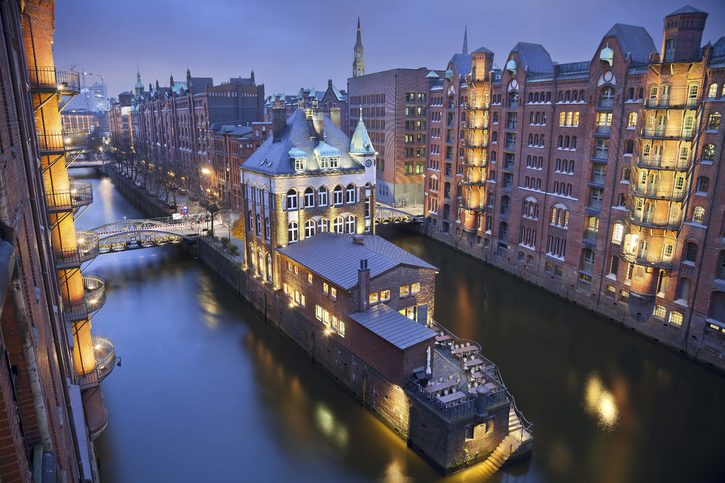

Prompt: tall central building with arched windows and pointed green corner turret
[{"left": 240, "top": 97, "right": 376, "bottom": 287}]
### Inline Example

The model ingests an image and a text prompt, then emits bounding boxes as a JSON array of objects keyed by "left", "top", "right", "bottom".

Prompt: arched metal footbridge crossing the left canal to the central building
[{"left": 90, "top": 214, "right": 207, "bottom": 253}]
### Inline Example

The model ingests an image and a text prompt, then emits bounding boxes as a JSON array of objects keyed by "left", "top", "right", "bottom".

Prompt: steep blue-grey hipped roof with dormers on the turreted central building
[{"left": 242, "top": 109, "right": 364, "bottom": 175}]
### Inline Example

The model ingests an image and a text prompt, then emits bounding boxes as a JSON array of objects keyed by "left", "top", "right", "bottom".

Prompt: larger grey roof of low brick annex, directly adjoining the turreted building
[{"left": 277, "top": 232, "right": 437, "bottom": 290}]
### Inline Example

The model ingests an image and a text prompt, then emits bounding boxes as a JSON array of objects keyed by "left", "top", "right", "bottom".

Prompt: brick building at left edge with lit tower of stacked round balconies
[{"left": 0, "top": 0, "right": 111, "bottom": 482}]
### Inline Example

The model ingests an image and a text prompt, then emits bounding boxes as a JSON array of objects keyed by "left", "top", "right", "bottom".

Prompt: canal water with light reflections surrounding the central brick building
[{"left": 74, "top": 171, "right": 725, "bottom": 483}]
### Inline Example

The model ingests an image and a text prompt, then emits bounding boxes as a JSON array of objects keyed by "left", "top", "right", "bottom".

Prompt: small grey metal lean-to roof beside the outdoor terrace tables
[{"left": 348, "top": 304, "right": 436, "bottom": 349}]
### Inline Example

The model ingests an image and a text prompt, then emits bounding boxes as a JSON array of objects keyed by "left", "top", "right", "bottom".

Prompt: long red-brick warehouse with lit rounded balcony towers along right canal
[{"left": 426, "top": 7, "right": 725, "bottom": 368}]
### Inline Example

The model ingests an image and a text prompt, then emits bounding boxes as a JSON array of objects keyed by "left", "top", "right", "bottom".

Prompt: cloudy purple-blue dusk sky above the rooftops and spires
[{"left": 55, "top": 0, "right": 725, "bottom": 100}]
